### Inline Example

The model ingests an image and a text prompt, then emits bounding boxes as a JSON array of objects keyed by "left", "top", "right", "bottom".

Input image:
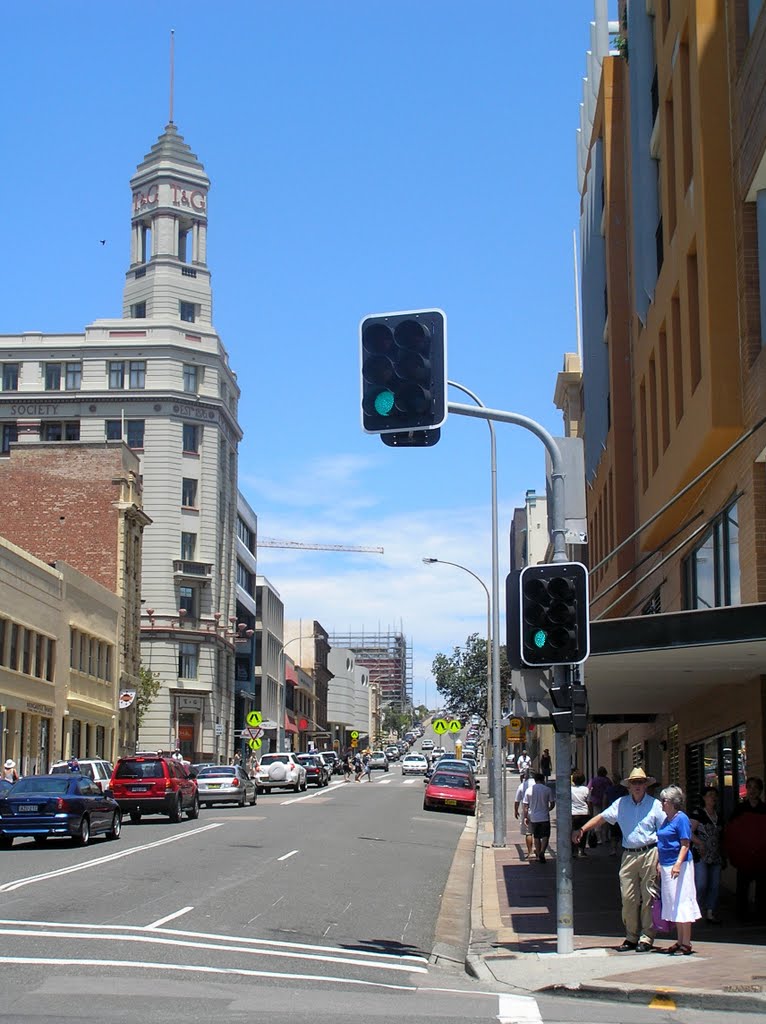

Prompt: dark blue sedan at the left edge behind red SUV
[{"left": 0, "top": 773, "right": 122, "bottom": 849}]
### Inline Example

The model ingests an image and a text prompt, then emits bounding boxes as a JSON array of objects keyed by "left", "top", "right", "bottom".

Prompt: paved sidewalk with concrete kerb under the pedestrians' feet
[{"left": 466, "top": 775, "right": 766, "bottom": 1015}]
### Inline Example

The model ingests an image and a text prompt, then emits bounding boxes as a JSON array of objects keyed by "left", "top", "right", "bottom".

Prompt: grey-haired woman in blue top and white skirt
[{"left": 657, "top": 785, "right": 701, "bottom": 956}]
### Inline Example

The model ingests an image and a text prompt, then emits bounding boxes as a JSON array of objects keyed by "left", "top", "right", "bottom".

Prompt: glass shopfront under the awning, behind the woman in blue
[{"left": 686, "top": 725, "right": 748, "bottom": 819}]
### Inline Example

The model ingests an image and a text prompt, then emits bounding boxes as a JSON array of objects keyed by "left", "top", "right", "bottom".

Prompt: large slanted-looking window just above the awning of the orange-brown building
[{"left": 684, "top": 502, "right": 741, "bottom": 608}]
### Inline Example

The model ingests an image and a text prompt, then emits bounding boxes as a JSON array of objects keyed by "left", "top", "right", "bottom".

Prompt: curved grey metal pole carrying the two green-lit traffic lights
[{"left": 448, "top": 401, "right": 575, "bottom": 953}]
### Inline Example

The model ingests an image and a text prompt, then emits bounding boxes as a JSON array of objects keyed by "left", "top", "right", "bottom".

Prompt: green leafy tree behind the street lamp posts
[{"left": 431, "top": 633, "right": 511, "bottom": 725}]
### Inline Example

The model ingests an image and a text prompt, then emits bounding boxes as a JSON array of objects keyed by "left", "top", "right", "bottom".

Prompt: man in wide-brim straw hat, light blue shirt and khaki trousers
[{"left": 571, "top": 768, "right": 665, "bottom": 953}]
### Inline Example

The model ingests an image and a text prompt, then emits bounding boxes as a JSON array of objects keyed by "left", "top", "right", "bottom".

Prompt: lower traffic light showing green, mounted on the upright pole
[{"left": 519, "top": 562, "right": 590, "bottom": 667}]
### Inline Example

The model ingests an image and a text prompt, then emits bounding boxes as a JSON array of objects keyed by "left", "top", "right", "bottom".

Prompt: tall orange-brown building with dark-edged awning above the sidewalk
[{"left": 573, "top": 0, "right": 766, "bottom": 798}]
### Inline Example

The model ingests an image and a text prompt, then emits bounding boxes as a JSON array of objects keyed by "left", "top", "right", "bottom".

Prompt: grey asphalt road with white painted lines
[{"left": 0, "top": 765, "right": 753, "bottom": 1024}]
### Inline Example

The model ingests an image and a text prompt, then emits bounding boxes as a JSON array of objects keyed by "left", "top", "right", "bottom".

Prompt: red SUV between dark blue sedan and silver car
[{"left": 112, "top": 754, "right": 200, "bottom": 821}]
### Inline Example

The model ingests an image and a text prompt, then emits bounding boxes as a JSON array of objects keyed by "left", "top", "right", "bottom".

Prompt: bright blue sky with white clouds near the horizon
[{"left": 0, "top": 0, "right": 615, "bottom": 703}]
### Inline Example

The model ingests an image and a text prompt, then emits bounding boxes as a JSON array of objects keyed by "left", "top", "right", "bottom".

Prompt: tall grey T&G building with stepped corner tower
[{"left": 0, "top": 122, "right": 242, "bottom": 759}]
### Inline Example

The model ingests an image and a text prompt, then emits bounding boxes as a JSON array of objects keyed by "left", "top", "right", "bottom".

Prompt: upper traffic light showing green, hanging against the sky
[{"left": 359, "top": 309, "right": 446, "bottom": 436}]
